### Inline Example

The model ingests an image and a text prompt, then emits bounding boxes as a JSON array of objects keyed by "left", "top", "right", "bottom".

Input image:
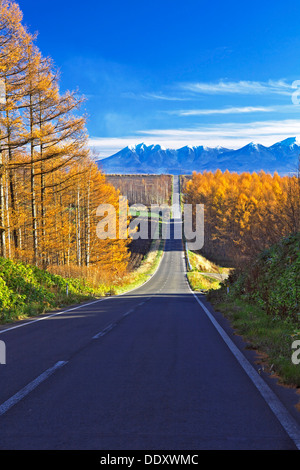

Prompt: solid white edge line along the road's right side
[{"left": 188, "top": 282, "right": 300, "bottom": 450}]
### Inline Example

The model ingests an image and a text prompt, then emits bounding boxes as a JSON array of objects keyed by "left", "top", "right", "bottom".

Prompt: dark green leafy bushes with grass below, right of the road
[{"left": 208, "top": 233, "right": 300, "bottom": 387}]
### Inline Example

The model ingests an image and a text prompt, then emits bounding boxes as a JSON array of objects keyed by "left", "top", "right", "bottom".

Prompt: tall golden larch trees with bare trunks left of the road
[{"left": 0, "top": 0, "right": 128, "bottom": 273}]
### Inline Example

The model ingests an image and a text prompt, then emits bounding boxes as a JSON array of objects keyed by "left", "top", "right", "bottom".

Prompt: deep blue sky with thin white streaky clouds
[{"left": 18, "top": 0, "right": 300, "bottom": 158}]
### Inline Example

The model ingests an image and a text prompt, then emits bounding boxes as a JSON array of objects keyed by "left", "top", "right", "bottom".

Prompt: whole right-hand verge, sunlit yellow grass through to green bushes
[{"left": 187, "top": 237, "right": 300, "bottom": 388}]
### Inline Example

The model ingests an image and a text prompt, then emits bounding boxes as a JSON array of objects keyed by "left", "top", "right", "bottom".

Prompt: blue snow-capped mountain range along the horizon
[{"left": 97, "top": 137, "right": 300, "bottom": 175}]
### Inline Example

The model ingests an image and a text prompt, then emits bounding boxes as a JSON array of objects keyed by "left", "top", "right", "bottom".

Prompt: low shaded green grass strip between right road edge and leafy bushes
[{"left": 207, "top": 288, "right": 300, "bottom": 387}]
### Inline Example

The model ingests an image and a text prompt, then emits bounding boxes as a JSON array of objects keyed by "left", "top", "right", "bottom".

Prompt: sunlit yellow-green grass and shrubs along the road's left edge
[{"left": 0, "top": 235, "right": 164, "bottom": 324}]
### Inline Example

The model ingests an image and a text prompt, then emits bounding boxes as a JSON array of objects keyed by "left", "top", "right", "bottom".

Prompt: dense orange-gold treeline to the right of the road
[{"left": 183, "top": 170, "right": 300, "bottom": 266}]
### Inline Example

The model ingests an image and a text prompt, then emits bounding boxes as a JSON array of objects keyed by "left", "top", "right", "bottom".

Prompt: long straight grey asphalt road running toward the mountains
[{"left": 0, "top": 178, "right": 300, "bottom": 450}]
